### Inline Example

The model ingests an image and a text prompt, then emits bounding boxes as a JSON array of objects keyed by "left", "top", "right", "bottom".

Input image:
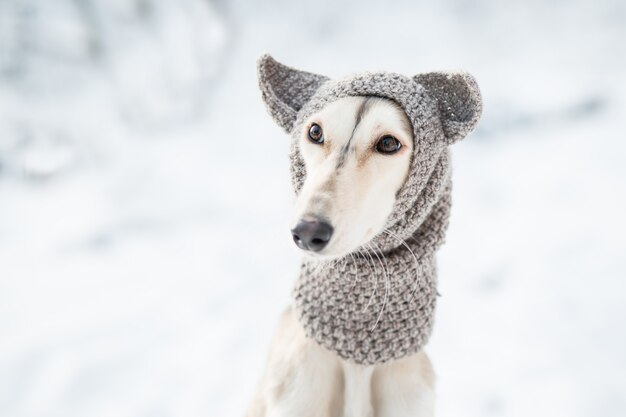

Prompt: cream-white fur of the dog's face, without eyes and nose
[{"left": 292, "top": 97, "right": 413, "bottom": 258}]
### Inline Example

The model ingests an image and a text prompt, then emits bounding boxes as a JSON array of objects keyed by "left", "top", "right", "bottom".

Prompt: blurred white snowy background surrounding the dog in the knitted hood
[{"left": 0, "top": 0, "right": 626, "bottom": 417}]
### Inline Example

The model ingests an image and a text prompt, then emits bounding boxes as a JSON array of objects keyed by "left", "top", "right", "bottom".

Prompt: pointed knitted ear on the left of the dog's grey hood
[{"left": 257, "top": 54, "right": 328, "bottom": 132}]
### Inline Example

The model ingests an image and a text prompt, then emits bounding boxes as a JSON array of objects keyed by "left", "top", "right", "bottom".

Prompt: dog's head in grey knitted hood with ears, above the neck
[{"left": 258, "top": 55, "right": 481, "bottom": 258}]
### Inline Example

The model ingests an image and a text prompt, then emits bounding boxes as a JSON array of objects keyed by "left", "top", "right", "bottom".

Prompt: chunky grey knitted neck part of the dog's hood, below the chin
[{"left": 293, "top": 153, "right": 451, "bottom": 364}]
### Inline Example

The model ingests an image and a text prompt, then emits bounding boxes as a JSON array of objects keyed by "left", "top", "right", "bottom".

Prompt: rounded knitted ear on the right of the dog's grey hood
[{"left": 414, "top": 72, "right": 483, "bottom": 145}]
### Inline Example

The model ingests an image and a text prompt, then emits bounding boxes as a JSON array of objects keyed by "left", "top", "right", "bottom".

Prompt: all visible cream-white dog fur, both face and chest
[{"left": 247, "top": 97, "right": 434, "bottom": 417}]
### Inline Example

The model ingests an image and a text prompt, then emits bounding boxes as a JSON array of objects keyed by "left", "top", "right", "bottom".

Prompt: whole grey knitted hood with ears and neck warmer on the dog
[{"left": 258, "top": 55, "right": 482, "bottom": 364}]
